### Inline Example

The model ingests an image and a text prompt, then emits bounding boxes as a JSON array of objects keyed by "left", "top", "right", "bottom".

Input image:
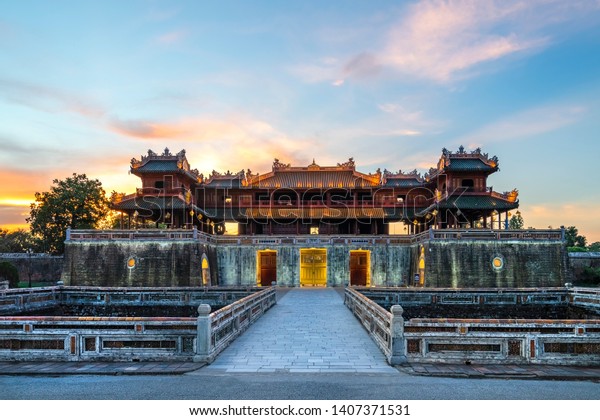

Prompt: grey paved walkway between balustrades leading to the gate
[{"left": 203, "top": 288, "right": 397, "bottom": 373}]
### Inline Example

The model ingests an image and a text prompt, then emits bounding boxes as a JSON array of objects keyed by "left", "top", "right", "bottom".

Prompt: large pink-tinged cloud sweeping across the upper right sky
[{"left": 296, "top": 0, "right": 599, "bottom": 83}]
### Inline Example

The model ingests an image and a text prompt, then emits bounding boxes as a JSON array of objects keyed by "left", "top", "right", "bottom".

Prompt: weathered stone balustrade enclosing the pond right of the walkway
[{"left": 345, "top": 288, "right": 600, "bottom": 365}]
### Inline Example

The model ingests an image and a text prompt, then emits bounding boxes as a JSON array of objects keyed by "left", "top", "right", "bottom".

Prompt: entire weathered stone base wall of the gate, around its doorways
[{"left": 62, "top": 239, "right": 571, "bottom": 288}]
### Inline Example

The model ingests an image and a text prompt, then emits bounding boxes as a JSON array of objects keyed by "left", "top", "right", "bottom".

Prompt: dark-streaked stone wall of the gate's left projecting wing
[{"left": 62, "top": 240, "right": 217, "bottom": 287}]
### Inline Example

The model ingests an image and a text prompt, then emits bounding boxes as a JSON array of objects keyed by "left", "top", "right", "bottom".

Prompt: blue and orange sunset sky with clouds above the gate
[{"left": 0, "top": 0, "right": 600, "bottom": 242}]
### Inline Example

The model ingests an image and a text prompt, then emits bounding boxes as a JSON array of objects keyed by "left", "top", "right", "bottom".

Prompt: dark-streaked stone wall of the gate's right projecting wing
[{"left": 422, "top": 240, "right": 570, "bottom": 288}]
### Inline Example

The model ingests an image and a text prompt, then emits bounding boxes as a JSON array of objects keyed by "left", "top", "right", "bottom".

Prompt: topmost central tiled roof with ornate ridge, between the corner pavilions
[{"left": 249, "top": 170, "right": 380, "bottom": 188}]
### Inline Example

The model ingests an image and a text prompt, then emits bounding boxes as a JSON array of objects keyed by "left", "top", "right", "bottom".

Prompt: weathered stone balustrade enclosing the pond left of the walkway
[{"left": 0, "top": 287, "right": 276, "bottom": 362}]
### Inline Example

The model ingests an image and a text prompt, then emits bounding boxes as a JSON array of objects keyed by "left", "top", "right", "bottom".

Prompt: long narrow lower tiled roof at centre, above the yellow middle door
[{"left": 246, "top": 208, "right": 386, "bottom": 220}]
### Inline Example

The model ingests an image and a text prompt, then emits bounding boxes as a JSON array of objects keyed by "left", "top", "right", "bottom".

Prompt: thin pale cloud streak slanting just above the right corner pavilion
[{"left": 455, "top": 105, "right": 586, "bottom": 148}]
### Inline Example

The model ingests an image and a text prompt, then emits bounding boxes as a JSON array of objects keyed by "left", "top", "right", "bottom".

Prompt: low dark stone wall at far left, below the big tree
[{"left": 0, "top": 253, "right": 63, "bottom": 284}]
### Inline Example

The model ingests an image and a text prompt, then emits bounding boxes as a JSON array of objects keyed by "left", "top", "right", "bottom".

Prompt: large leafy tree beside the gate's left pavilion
[{"left": 27, "top": 174, "right": 109, "bottom": 254}]
